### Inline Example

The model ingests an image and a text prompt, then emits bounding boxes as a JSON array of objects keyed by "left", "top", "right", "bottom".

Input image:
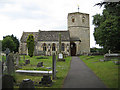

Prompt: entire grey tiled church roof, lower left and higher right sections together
[{"left": 20, "top": 31, "right": 70, "bottom": 42}]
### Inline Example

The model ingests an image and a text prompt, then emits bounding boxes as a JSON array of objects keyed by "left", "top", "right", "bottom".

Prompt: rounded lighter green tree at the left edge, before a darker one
[{"left": 2, "top": 37, "right": 16, "bottom": 52}]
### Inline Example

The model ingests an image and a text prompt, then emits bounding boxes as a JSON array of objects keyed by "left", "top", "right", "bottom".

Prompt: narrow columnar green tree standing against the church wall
[{"left": 27, "top": 34, "right": 34, "bottom": 57}]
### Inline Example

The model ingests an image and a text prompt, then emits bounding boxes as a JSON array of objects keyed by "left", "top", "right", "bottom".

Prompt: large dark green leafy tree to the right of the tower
[{"left": 93, "top": 2, "right": 120, "bottom": 52}]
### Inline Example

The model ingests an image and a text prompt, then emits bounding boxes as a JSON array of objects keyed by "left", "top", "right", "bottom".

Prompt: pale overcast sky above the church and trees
[{"left": 0, "top": 0, "right": 103, "bottom": 47}]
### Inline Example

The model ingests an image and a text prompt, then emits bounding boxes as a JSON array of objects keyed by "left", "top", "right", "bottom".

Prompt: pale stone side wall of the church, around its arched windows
[{"left": 19, "top": 41, "right": 70, "bottom": 55}]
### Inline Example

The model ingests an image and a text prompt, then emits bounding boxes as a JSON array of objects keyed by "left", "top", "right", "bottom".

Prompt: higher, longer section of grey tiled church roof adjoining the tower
[{"left": 38, "top": 31, "right": 70, "bottom": 41}]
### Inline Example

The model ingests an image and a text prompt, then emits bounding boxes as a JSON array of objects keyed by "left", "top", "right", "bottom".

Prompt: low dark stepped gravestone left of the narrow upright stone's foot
[{"left": 39, "top": 75, "right": 52, "bottom": 86}]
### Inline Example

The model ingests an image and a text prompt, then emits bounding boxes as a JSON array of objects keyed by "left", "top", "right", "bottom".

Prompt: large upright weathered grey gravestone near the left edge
[{"left": 6, "top": 53, "right": 15, "bottom": 74}]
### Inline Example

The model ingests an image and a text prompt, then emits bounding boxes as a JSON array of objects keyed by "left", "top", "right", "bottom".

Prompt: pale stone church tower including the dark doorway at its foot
[{"left": 68, "top": 12, "right": 90, "bottom": 55}]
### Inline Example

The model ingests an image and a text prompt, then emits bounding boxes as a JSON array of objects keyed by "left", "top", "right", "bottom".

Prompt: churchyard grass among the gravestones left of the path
[{"left": 14, "top": 56, "right": 71, "bottom": 88}]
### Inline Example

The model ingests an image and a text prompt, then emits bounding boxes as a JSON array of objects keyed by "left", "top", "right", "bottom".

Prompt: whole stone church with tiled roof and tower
[{"left": 19, "top": 12, "right": 90, "bottom": 56}]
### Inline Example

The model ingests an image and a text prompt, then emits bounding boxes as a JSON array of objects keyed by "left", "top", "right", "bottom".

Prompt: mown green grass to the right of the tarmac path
[{"left": 80, "top": 56, "right": 120, "bottom": 88}]
